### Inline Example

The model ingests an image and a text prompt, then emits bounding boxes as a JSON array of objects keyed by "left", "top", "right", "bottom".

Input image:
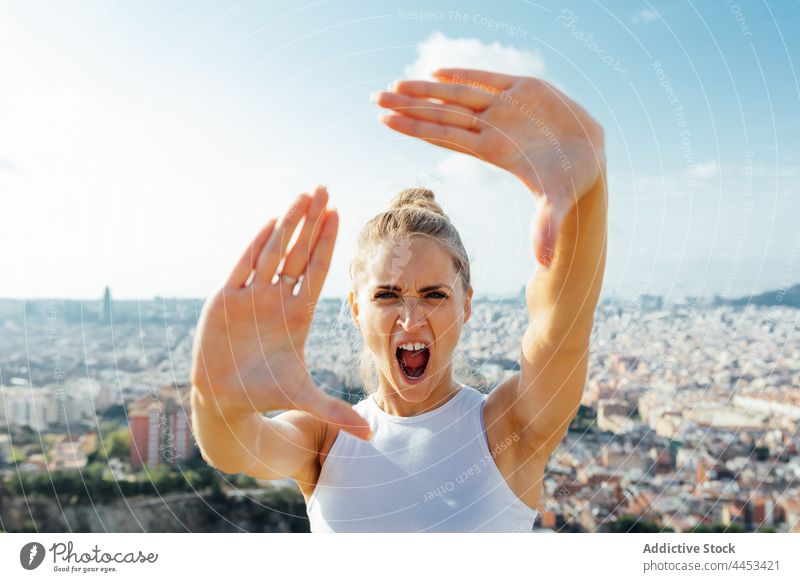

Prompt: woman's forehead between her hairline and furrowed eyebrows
[{"left": 364, "top": 236, "right": 458, "bottom": 287}]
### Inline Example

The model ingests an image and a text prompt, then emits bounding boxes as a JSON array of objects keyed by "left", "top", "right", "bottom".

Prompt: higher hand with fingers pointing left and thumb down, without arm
[{"left": 372, "top": 69, "right": 605, "bottom": 266}]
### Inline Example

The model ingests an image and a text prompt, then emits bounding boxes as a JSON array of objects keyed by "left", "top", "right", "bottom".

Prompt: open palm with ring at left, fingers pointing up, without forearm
[{"left": 191, "top": 187, "right": 369, "bottom": 438}]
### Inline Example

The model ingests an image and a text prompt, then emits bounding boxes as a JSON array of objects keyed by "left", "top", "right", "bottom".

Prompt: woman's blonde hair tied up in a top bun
[{"left": 340, "top": 188, "right": 472, "bottom": 393}]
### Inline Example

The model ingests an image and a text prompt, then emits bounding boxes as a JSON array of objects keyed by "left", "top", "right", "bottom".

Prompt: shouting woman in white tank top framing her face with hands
[{"left": 191, "top": 69, "right": 607, "bottom": 531}]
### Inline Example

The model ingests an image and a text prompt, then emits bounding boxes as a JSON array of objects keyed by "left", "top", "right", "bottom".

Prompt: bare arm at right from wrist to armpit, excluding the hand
[{"left": 513, "top": 172, "right": 608, "bottom": 456}]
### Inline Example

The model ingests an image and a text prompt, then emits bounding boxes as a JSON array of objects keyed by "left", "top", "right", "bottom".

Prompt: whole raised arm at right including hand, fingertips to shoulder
[{"left": 375, "top": 69, "right": 608, "bottom": 458}]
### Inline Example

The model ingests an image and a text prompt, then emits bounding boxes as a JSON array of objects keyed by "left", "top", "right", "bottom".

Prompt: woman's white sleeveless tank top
[{"left": 307, "top": 385, "right": 537, "bottom": 533}]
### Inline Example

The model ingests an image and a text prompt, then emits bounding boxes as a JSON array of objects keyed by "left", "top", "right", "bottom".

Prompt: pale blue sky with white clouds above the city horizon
[{"left": 0, "top": 0, "right": 800, "bottom": 299}]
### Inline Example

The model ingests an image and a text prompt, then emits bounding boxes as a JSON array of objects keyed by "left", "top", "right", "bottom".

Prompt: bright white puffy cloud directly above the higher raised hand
[{"left": 404, "top": 31, "right": 547, "bottom": 79}]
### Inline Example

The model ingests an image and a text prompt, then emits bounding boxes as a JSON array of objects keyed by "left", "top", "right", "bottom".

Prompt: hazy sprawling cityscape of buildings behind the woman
[{"left": 0, "top": 285, "right": 800, "bottom": 532}]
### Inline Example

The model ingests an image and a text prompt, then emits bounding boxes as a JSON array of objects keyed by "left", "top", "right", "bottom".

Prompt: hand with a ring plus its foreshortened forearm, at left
[{"left": 191, "top": 187, "right": 369, "bottom": 479}]
